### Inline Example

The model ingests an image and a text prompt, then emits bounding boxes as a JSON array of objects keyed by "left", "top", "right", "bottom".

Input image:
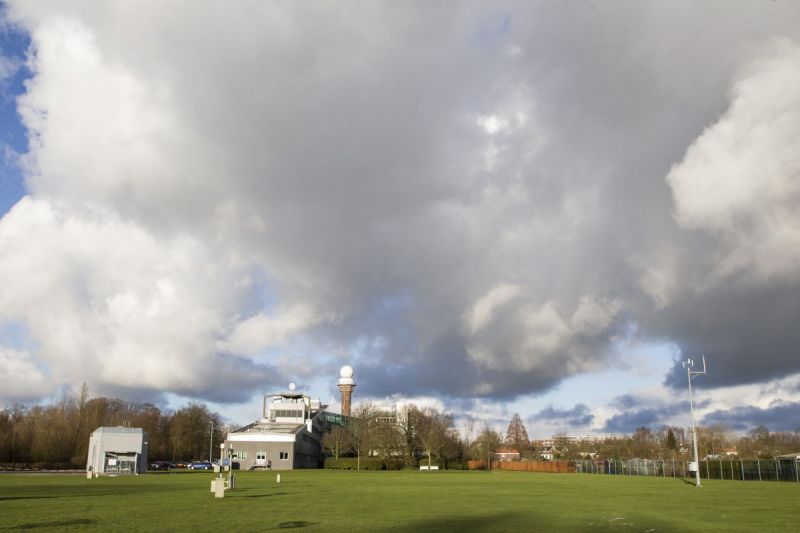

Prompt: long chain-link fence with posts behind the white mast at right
[{"left": 575, "top": 458, "right": 800, "bottom": 483}]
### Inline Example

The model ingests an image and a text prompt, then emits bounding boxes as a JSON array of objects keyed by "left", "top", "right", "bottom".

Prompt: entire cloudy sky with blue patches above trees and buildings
[{"left": 0, "top": 0, "right": 800, "bottom": 437}]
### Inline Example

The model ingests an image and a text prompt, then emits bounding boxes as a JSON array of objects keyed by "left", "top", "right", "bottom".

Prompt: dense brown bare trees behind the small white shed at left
[{"left": 0, "top": 385, "right": 229, "bottom": 468}]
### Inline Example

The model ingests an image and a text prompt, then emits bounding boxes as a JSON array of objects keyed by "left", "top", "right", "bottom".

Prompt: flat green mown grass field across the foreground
[{"left": 0, "top": 470, "right": 800, "bottom": 532}]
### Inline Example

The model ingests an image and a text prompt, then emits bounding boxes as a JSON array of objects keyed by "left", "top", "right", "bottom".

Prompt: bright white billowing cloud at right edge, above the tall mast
[{"left": 667, "top": 39, "right": 800, "bottom": 282}]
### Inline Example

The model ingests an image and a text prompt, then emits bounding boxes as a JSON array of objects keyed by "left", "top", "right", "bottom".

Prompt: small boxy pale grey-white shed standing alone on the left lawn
[{"left": 86, "top": 427, "right": 147, "bottom": 475}]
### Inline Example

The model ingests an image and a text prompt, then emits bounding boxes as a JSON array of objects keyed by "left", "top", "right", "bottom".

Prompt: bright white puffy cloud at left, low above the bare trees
[{"left": 0, "top": 197, "right": 278, "bottom": 391}]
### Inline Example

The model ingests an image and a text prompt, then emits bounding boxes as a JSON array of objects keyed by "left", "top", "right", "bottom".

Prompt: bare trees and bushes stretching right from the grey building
[{"left": 323, "top": 402, "right": 800, "bottom": 468}]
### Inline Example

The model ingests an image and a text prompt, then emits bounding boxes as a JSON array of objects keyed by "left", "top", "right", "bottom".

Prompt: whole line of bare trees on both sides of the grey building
[{"left": 0, "top": 385, "right": 800, "bottom": 469}]
